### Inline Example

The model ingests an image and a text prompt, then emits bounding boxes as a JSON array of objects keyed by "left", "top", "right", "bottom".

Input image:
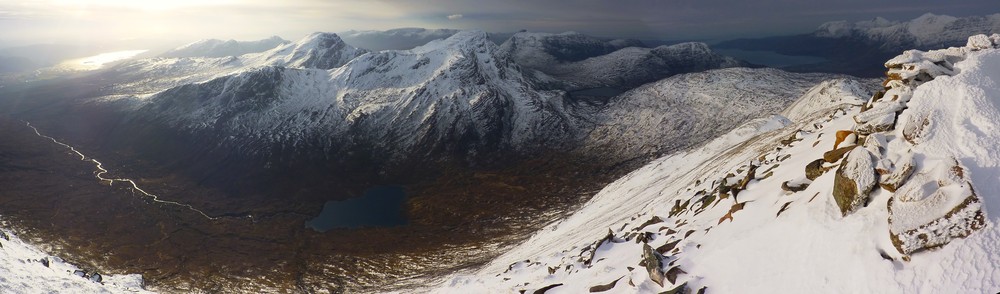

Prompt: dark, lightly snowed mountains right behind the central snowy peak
[{"left": 501, "top": 32, "right": 747, "bottom": 89}]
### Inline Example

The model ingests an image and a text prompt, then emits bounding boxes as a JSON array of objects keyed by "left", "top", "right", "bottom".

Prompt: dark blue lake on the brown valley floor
[{"left": 306, "top": 186, "right": 407, "bottom": 232}]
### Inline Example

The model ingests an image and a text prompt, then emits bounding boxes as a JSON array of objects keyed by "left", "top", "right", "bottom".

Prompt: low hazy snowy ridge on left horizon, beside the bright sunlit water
[{"left": 160, "top": 36, "right": 288, "bottom": 58}]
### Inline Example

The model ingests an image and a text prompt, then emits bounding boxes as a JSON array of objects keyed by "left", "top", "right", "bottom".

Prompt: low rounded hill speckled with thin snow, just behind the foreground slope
[{"left": 585, "top": 68, "right": 852, "bottom": 159}]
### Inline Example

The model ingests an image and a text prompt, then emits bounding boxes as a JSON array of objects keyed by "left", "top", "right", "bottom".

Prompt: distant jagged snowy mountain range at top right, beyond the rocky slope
[{"left": 814, "top": 13, "right": 1000, "bottom": 52}]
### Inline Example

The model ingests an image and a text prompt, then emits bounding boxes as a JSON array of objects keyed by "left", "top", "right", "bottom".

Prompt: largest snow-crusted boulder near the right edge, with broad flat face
[{"left": 887, "top": 159, "right": 986, "bottom": 254}]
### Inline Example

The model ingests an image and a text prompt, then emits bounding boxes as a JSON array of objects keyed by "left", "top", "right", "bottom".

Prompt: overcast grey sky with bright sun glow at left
[{"left": 0, "top": 0, "right": 1000, "bottom": 45}]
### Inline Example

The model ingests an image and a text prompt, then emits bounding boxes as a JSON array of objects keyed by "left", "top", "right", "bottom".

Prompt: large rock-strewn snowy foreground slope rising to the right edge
[{"left": 434, "top": 35, "right": 1000, "bottom": 293}]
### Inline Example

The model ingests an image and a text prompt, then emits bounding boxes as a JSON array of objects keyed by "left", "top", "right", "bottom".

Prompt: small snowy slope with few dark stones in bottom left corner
[{"left": 0, "top": 225, "right": 146, "bottom": 293}]
